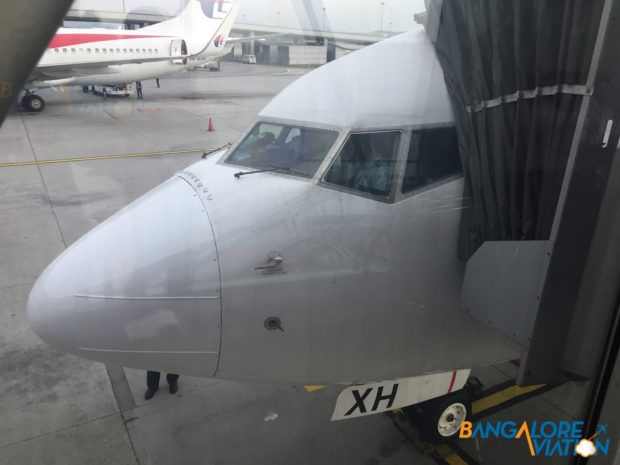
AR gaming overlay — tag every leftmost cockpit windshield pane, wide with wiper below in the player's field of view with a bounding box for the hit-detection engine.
[226,122,338,178]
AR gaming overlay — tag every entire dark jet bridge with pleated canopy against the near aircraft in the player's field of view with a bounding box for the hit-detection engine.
[424,0,620,456]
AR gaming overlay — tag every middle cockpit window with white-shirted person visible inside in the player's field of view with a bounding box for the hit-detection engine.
[323,131,400,197]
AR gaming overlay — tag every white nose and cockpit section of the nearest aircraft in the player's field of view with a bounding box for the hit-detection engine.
[28,27,518,386]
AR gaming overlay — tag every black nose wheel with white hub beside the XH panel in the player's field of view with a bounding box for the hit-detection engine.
[403,391,471,443]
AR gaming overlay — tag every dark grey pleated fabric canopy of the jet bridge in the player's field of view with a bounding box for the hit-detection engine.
[431,0,603,258]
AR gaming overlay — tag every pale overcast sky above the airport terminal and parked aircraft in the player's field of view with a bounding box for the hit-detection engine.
[72,0,424,32]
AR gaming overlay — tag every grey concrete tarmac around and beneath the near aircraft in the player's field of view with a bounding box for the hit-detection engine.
[0,62,600,465]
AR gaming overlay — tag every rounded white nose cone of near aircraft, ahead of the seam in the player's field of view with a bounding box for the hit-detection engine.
[28,177,221,376]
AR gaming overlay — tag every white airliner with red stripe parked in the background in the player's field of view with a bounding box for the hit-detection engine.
[21,0,237,112]
